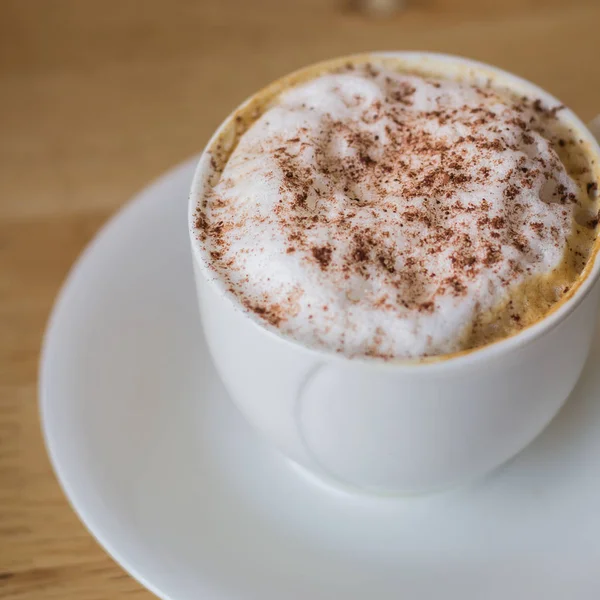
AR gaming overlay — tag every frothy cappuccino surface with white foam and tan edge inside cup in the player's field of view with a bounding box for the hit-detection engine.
[196,60,598,359]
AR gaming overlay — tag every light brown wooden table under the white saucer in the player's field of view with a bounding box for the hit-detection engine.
[0,0,600,600]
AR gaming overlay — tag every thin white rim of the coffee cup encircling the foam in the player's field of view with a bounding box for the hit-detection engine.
[188,51,600,373]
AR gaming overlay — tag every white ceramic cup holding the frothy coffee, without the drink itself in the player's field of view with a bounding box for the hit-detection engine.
[189,52,600,494]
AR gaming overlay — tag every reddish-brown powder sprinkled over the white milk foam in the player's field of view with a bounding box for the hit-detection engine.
[196,65,595,352]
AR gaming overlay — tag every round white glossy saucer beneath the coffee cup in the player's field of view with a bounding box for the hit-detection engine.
[41,162,600,600]
